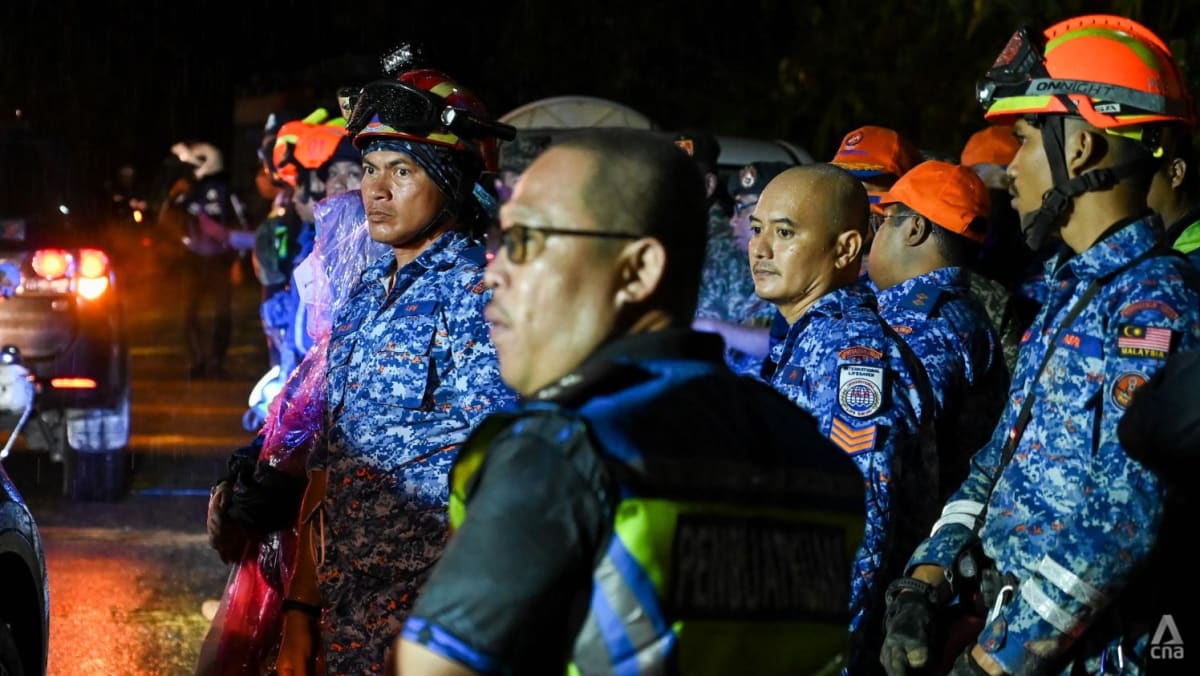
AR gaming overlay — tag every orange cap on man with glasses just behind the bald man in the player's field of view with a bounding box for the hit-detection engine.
[880,160,991,241]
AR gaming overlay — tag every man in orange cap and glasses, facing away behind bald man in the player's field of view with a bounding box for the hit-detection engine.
[869,161,1008,501]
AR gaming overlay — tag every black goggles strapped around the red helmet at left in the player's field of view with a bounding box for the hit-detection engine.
[337,80,517,140]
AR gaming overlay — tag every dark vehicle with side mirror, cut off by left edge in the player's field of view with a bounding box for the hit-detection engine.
[0,347,50,676]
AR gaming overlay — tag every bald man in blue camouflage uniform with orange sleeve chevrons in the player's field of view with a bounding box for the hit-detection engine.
[749,164,937,674]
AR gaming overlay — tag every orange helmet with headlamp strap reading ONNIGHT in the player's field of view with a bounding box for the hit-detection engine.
[977,14,1195,130]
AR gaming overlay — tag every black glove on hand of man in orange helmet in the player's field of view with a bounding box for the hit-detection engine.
[880,578,935,676]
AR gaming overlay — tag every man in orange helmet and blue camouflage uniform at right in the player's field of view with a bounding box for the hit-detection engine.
[881,16,1200,675]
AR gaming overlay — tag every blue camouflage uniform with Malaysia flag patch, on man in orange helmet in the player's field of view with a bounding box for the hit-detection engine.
[910,217,1200,674]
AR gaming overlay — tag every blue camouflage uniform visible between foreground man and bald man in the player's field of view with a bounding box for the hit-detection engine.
[696,207,775,375]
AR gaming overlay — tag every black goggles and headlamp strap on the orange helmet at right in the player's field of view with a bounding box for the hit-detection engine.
[976,26,1188,116]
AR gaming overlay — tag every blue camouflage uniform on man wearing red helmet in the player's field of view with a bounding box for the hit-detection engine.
[313,233,515,674]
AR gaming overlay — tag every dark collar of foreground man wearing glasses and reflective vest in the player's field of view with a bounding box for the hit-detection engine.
[529,329,725,405]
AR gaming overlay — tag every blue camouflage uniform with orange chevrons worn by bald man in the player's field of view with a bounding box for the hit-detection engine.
[763,283,937,674]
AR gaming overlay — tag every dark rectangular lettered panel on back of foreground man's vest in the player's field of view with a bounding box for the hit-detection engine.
[670,515,850,620]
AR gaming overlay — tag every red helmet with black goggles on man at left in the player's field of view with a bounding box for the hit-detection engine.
[338,68,516,172]
